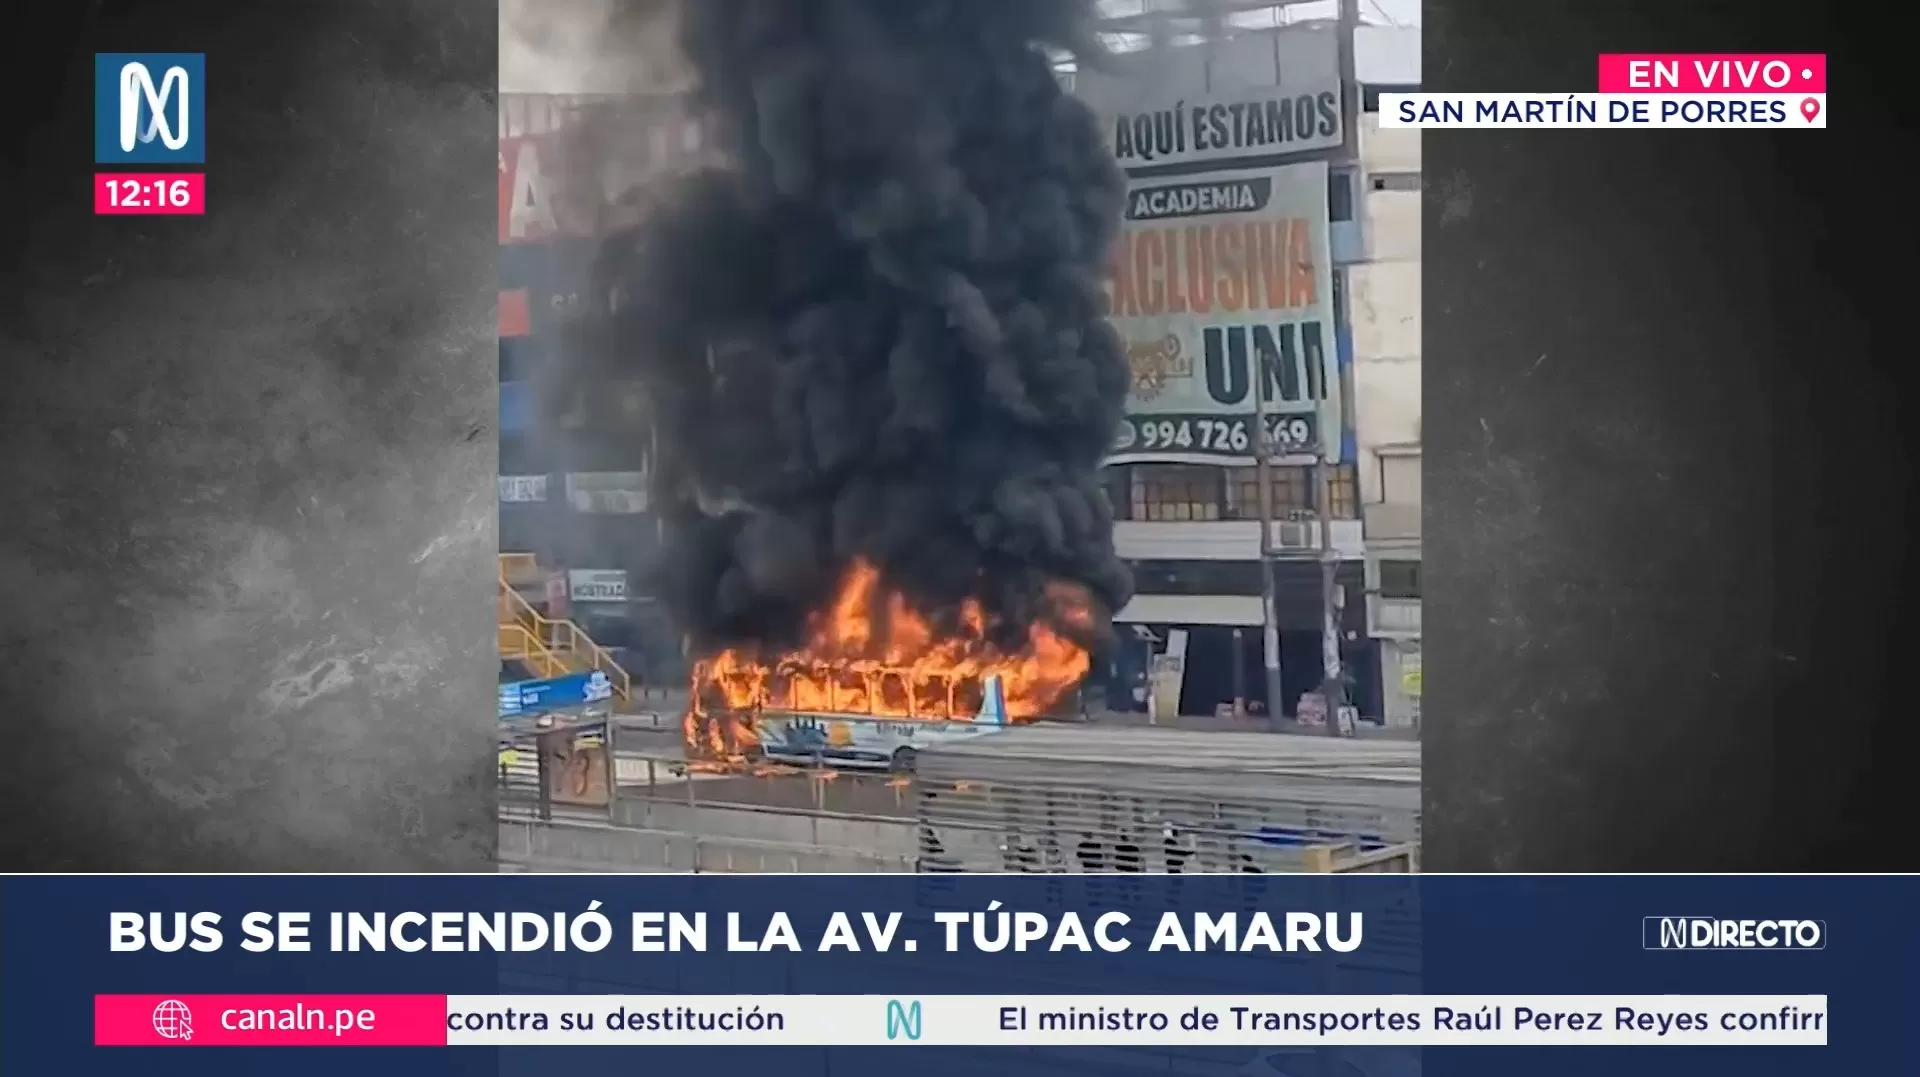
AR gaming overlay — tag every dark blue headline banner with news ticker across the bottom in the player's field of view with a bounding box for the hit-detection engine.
[0,879,1920,1077]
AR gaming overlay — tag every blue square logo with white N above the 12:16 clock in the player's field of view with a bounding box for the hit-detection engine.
[94,52,207,165]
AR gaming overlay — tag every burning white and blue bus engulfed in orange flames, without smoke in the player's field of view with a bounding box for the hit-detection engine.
[684,562,1091,770]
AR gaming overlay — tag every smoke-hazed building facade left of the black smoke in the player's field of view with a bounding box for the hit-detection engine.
[499,94,701,683]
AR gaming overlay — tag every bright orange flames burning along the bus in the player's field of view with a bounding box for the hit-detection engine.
[684,561,1092,762]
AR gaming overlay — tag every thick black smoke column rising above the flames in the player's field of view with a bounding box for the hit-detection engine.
[601,0,1131,649]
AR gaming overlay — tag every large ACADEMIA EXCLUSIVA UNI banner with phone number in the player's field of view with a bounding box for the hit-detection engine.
[1108,161,1342,465]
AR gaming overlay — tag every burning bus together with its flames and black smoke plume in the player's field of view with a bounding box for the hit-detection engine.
[568,0,1133,766]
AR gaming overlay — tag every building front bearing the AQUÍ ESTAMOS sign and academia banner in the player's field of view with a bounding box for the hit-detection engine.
[1069,23,1384,718]
